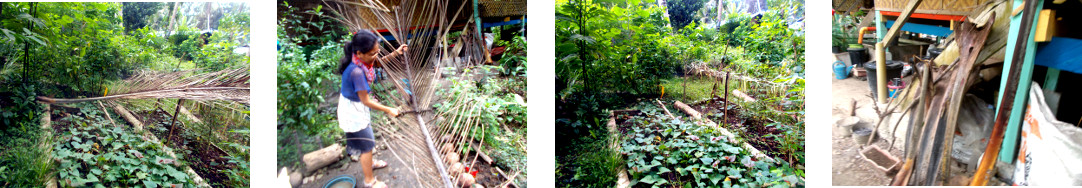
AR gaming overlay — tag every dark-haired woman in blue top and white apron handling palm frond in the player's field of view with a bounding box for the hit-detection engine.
[334,30,407,187]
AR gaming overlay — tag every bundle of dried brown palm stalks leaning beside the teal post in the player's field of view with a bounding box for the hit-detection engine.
[891,7,997,186]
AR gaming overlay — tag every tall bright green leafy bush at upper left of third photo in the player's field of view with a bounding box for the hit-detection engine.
[556,1,678,96]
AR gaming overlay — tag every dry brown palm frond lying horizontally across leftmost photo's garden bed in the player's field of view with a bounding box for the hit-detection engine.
[37,67,250,104]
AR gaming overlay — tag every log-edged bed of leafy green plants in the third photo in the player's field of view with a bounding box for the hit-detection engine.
[612,105,803,187]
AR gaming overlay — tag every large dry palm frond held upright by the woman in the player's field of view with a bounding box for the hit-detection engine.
[324,0,495,187]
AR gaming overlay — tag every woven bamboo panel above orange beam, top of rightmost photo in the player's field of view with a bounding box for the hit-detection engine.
[875,0,992,15]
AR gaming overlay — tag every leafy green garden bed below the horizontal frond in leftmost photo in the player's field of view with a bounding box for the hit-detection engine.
[50,103,199,187]
